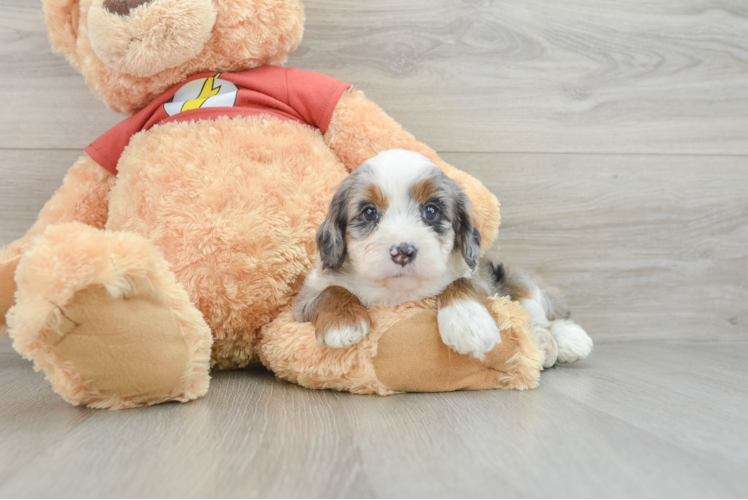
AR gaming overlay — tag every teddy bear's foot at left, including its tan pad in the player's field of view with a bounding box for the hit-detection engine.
[7,223,212,408]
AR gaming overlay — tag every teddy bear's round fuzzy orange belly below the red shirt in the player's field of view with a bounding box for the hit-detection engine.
[106,117,347,368]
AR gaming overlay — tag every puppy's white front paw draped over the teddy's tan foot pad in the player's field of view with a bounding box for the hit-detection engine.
[437,300,501,360]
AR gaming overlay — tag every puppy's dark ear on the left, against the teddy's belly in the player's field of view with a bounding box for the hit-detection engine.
[317,176,352,269]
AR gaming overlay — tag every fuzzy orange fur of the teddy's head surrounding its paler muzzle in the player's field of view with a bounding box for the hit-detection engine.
[44,0,304,113]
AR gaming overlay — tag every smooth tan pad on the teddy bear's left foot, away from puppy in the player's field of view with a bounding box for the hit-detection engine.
[45,285,190,402]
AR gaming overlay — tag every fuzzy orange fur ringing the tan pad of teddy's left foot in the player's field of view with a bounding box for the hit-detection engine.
[7,223,212,408]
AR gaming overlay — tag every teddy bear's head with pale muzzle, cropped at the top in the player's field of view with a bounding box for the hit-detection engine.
[44,0,304,113]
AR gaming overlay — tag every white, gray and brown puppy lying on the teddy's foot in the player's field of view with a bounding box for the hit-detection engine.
[294,150,592,366]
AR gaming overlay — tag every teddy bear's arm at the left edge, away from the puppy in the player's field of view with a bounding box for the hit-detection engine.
[0,156,115,263]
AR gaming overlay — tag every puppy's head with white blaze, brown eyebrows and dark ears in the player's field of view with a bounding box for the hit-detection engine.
[317,150,480,290]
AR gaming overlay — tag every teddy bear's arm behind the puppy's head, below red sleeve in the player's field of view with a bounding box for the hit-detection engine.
[324,90,499,252]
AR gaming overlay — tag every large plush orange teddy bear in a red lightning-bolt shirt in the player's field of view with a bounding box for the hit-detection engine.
[0,0,540,408]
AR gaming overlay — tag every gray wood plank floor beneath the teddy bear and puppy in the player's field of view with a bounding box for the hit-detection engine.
[0,339,748,498]
